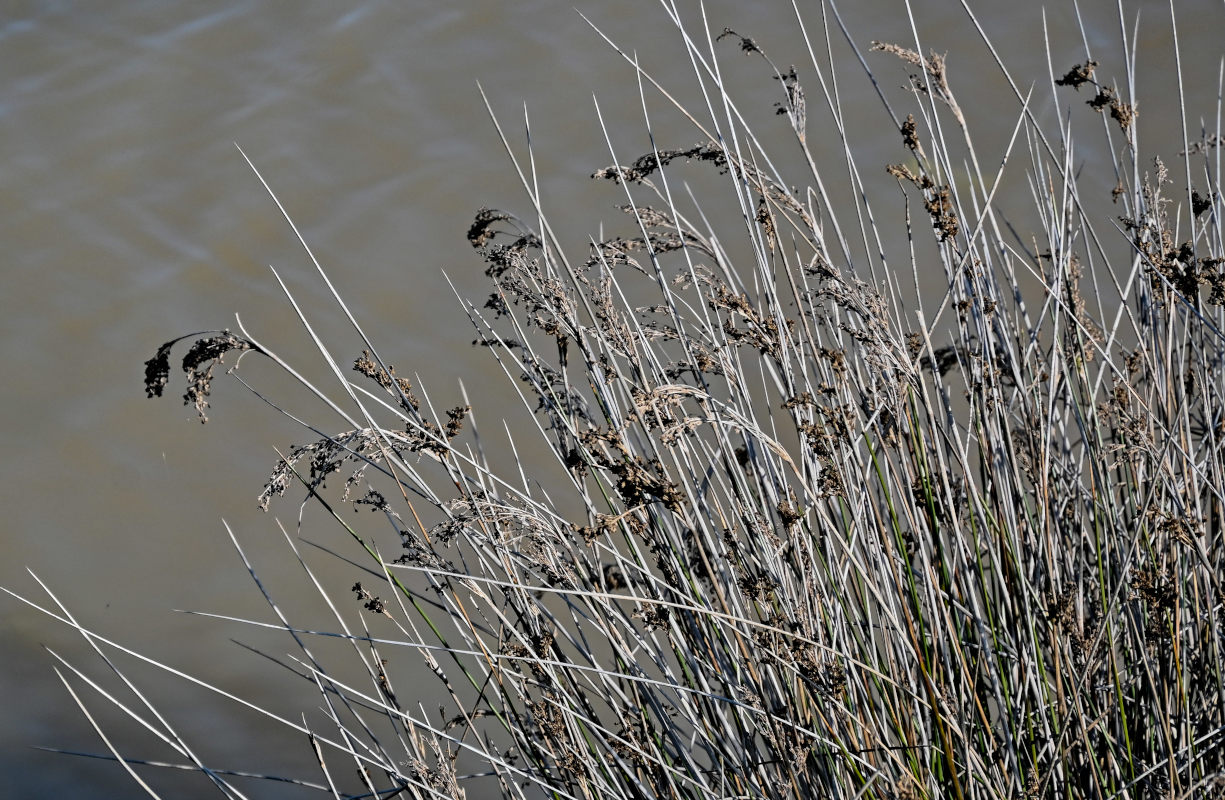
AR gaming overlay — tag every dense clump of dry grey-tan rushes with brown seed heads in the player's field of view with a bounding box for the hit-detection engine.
[11,1,1225,799]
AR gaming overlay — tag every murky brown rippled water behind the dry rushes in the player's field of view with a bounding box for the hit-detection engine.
[0,0,1225,798]
